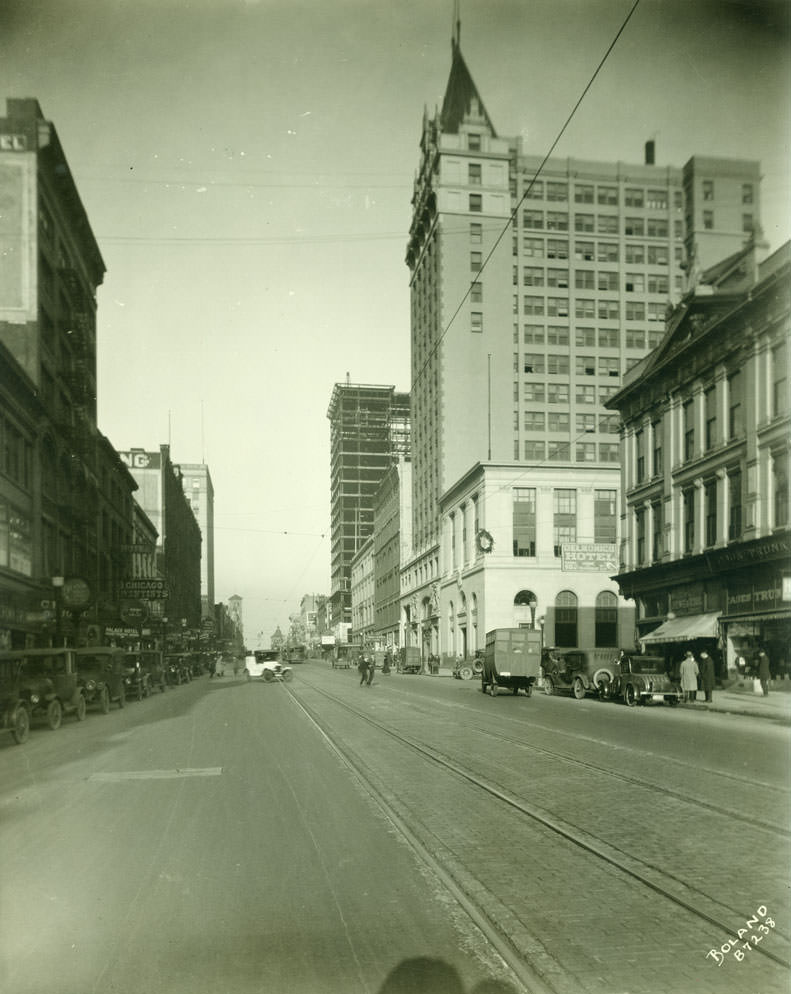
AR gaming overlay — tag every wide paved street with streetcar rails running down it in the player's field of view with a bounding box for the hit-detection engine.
[0,662,791,994]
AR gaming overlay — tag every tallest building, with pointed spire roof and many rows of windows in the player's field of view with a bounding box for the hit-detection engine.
[402,29,760,651]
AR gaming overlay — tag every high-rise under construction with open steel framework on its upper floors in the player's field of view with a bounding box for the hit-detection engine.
[327,380,410,633]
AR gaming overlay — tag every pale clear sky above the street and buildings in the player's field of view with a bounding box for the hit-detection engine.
[0,0,791,646]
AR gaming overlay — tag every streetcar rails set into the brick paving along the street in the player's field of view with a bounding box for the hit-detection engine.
[289,684,791,989]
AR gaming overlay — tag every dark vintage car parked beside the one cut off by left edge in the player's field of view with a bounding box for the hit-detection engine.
[0,648,86,729]
